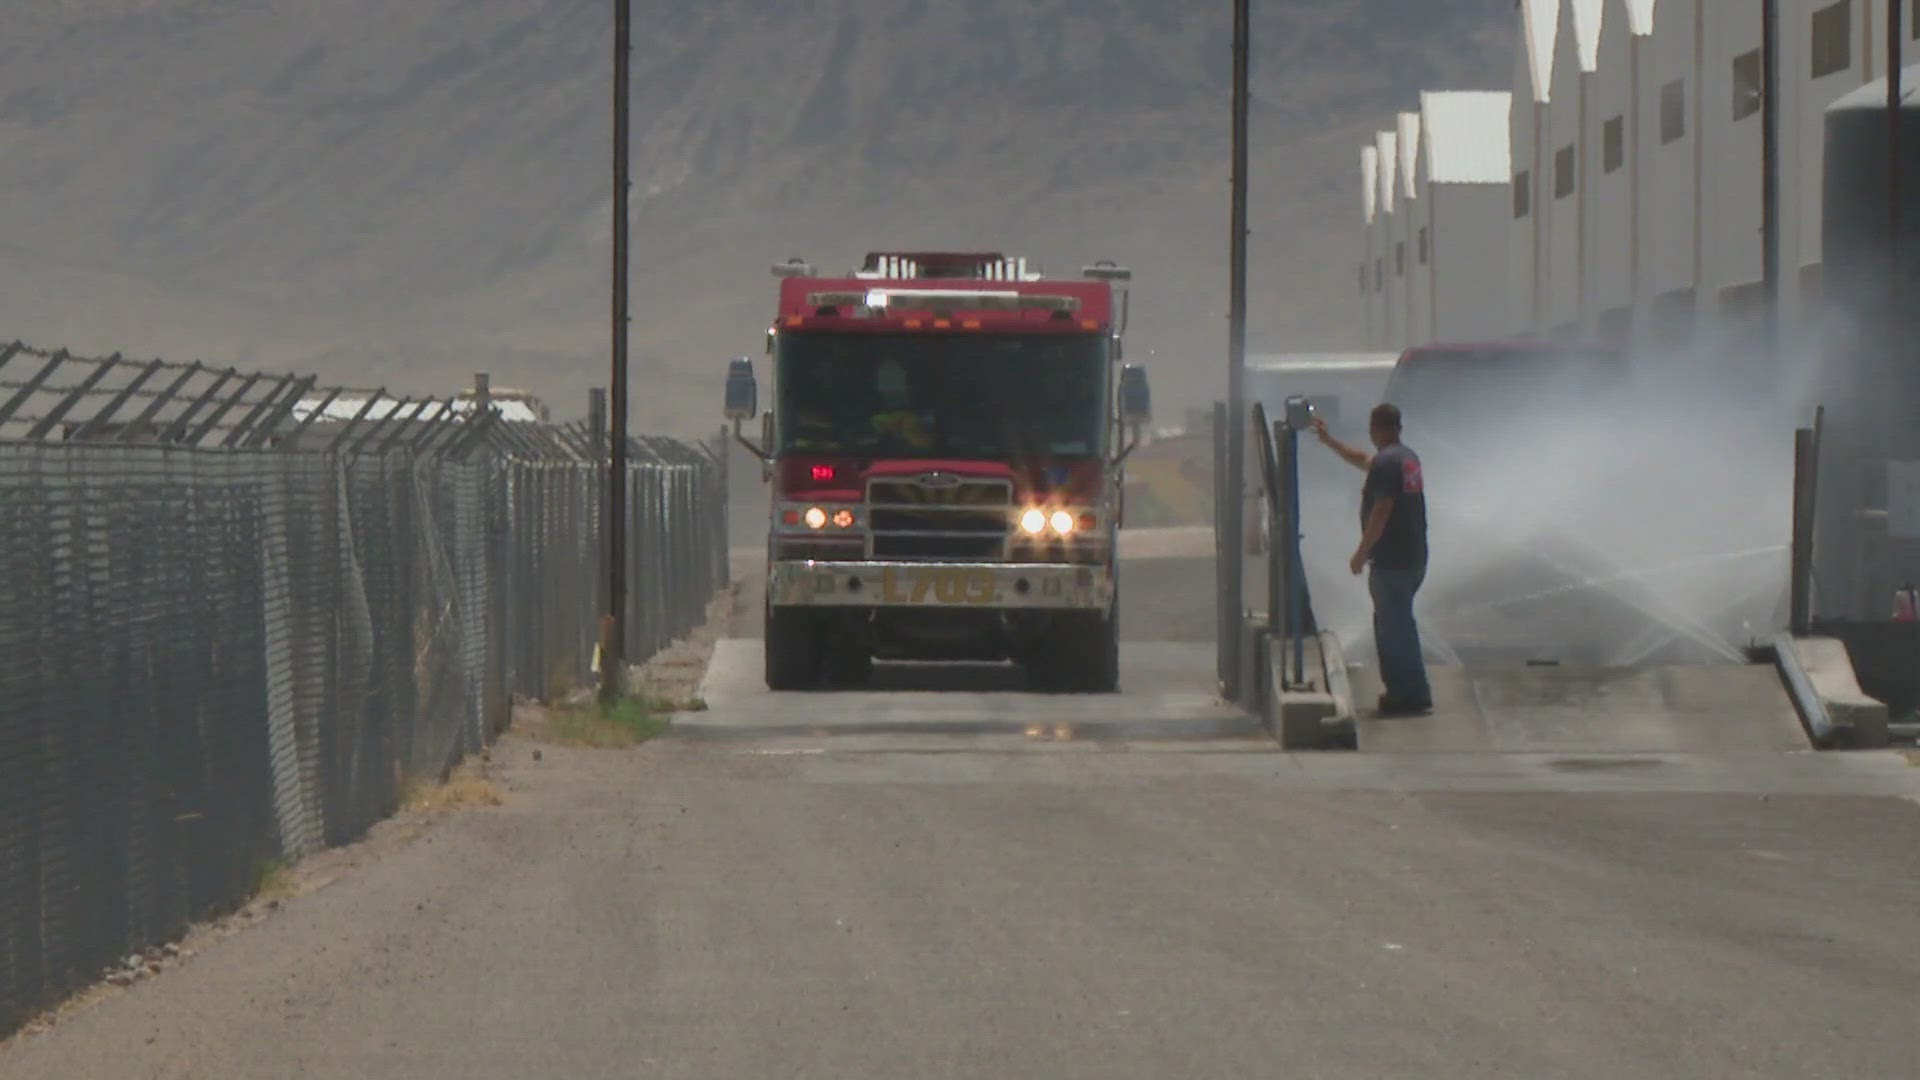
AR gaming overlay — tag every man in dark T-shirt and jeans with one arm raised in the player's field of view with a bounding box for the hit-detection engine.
[1313,405,1432,717]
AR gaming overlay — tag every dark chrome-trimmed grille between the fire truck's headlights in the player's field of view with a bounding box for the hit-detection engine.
[868,477,1014,561]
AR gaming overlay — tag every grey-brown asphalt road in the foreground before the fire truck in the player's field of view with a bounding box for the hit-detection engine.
[0,541,1920,1080]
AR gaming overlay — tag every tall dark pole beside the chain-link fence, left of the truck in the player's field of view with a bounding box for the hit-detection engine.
[599,0,634,703]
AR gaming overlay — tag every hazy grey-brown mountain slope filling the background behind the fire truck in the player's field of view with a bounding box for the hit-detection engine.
[0,0,1513,429]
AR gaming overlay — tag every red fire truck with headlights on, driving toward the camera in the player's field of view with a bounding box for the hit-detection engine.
[726,252,1148,692]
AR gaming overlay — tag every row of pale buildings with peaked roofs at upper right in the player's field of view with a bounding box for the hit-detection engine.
[1363,0,1920,350]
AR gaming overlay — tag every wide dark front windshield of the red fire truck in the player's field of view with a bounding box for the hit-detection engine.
[776,332,1108,459]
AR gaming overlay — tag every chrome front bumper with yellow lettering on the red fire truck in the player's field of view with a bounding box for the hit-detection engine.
[766,561,1114,611]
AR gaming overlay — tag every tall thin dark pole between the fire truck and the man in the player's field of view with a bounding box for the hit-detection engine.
[1217,0,1252,698]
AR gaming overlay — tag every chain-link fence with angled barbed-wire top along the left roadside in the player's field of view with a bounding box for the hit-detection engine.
[0,346,728,1034]
